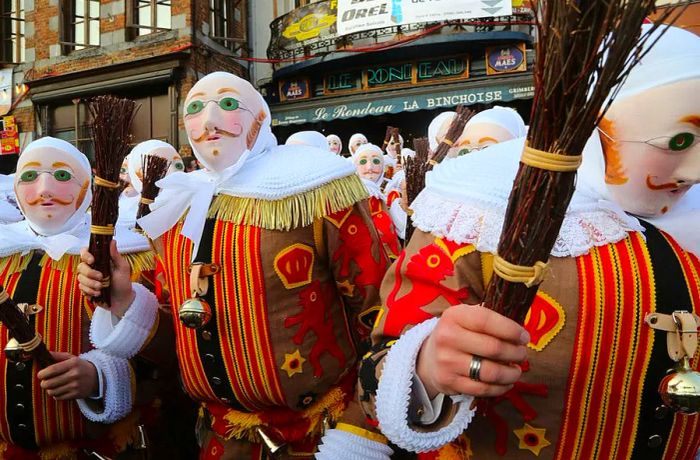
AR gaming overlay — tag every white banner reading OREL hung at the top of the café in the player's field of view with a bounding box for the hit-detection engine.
[337,0,513,35]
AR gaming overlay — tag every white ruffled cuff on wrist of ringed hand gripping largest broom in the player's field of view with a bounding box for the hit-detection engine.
[376,318,474,452]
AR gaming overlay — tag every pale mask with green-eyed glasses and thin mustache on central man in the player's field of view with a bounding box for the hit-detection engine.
[184,72,270,172]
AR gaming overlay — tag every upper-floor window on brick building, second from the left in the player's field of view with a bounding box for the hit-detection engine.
[61,0,100,54]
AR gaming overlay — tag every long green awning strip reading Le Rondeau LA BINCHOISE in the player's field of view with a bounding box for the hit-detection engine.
[272,78,535,126]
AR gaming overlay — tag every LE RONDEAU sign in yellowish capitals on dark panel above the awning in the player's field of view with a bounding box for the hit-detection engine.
[323,56,469,95]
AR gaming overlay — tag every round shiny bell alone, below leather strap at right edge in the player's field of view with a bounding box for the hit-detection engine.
[659,356,700,415]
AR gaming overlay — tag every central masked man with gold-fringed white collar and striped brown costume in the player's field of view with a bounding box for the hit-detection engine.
[81,72,388,459]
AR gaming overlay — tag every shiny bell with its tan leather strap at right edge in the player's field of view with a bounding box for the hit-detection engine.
[645,311,700,415]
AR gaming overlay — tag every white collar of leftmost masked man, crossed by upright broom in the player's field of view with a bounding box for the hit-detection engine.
[0,214,151,260]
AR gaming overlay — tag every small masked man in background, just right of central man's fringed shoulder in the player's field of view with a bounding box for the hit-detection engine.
[352,144,401,260]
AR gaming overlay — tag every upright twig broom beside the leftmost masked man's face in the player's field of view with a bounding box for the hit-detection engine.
[88,96,136,307]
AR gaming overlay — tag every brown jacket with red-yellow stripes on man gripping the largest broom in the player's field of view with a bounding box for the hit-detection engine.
[360,224,700,459]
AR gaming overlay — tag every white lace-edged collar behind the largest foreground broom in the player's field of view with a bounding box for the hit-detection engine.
[411,138,643,257]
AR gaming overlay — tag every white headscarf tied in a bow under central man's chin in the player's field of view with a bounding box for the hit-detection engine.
[138,72,278,256]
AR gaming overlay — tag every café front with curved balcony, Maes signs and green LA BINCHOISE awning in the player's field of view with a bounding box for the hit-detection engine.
[251,0,534,150]
